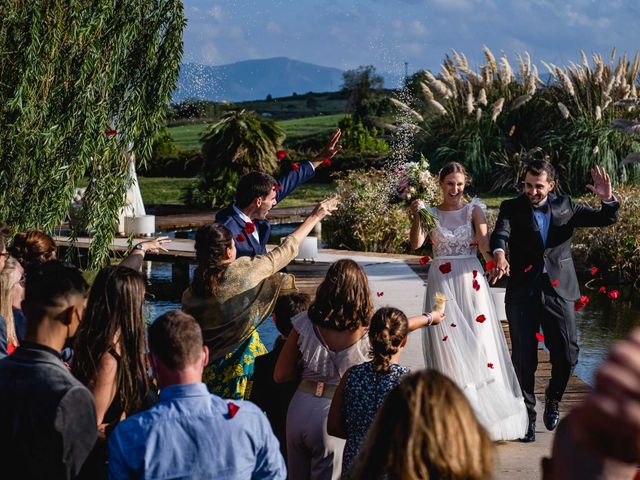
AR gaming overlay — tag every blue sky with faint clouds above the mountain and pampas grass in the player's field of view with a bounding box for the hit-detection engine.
[184,0,640,85]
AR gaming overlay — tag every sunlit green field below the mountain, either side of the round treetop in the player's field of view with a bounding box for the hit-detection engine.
[169,114,344,151]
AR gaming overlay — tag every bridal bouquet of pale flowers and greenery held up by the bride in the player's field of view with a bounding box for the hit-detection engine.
[397,156,440,232]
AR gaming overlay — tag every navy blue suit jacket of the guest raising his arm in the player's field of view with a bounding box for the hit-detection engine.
[216,162,315,257]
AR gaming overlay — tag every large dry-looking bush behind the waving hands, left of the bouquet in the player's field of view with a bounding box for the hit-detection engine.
[325,169,410,253]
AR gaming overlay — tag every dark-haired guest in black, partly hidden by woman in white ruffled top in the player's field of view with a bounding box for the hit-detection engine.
[250,293,311,458]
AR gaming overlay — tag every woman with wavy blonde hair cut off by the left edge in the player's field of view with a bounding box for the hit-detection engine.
[0,257,27,355]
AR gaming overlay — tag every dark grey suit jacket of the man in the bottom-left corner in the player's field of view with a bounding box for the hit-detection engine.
[0,341,97,479]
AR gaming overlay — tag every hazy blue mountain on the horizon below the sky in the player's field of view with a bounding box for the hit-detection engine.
[173,57,342,102]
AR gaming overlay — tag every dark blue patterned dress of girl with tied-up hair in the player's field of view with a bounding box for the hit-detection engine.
[342,362,410,478]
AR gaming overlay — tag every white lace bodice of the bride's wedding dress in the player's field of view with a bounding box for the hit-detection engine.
[431,198,487,257]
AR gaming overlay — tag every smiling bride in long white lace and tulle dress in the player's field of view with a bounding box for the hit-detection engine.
[410,162,528,440]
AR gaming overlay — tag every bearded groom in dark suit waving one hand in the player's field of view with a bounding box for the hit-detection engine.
[491,160,619,442]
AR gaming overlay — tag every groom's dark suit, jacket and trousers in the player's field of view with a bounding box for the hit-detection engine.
[491,194,619,419]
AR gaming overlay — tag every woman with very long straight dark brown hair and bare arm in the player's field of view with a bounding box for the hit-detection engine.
[71,266,151,478]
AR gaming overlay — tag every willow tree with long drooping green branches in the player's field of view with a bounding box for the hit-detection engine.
[0,0,185,267]
